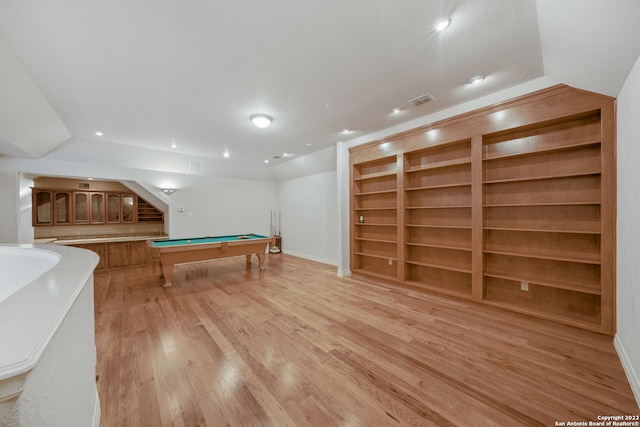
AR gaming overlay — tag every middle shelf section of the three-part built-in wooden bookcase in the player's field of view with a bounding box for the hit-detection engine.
[404,140,471,296]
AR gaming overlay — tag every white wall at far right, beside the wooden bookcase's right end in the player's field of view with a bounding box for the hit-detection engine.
[615,51,640,404]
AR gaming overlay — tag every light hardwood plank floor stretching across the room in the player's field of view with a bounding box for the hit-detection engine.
[95,254,640,427]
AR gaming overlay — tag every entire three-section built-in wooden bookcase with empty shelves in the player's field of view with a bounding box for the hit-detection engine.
[350,85,616,335]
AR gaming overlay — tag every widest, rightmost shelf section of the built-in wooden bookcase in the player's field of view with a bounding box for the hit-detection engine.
[483,111,603,325]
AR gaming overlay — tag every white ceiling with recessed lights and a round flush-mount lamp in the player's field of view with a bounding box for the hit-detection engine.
[0,0,640,172]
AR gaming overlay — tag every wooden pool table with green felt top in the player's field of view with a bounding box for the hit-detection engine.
[147,234,274,287]
